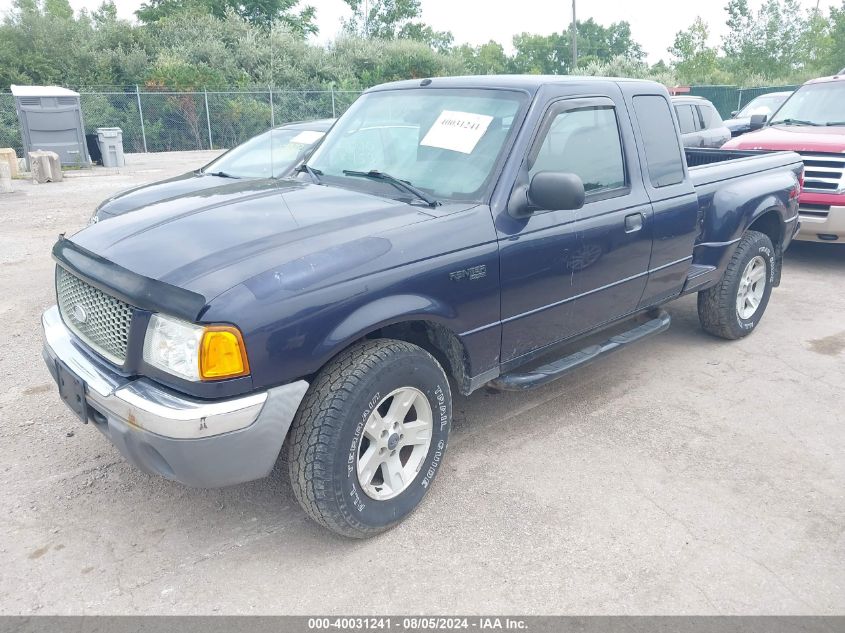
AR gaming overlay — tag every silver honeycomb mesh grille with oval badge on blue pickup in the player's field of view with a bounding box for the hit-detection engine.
[56,266,133,365]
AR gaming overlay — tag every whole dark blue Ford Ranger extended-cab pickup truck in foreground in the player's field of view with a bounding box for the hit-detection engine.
[43,76,803,537]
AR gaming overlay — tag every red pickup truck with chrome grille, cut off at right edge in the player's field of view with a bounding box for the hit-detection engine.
[722,69,845,243]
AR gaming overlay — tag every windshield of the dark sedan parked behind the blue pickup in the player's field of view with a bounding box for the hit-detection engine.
[202,129,324,178]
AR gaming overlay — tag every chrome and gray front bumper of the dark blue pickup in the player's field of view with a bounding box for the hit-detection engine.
[41,306,308,488]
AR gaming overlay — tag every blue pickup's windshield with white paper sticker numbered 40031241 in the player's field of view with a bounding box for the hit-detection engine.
[308,88,527,200]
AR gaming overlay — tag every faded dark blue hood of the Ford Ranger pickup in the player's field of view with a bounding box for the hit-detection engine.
[70,180,448,301]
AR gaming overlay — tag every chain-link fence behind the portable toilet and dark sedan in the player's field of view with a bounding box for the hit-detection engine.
[0,87,361,156]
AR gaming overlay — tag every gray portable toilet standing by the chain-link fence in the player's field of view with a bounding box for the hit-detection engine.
[12,85,91,169]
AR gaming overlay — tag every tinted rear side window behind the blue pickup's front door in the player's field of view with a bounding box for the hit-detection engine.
[634,95,684,188]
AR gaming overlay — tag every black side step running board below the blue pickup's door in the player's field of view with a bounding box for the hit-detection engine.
[489,310,672,391]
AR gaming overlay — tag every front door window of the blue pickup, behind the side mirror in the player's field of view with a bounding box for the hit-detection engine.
[529,106,625,196]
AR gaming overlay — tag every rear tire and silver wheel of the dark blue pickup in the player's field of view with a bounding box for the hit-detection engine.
[698,231,775,340]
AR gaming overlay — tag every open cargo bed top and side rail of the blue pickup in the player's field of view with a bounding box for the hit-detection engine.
[684,148,801,187]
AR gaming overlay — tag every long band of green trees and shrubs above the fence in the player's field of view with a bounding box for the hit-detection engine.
[0,0,845,90]
